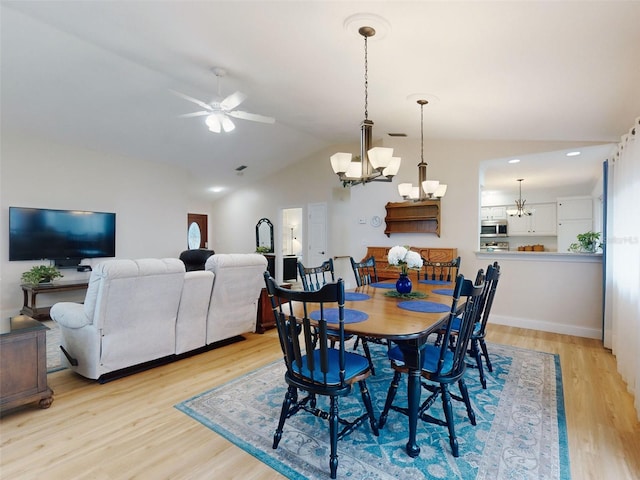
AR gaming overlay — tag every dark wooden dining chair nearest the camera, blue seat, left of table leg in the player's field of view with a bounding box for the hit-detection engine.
[264,272,378,478]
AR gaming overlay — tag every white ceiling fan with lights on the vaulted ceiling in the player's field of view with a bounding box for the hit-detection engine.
[172,67,276,133]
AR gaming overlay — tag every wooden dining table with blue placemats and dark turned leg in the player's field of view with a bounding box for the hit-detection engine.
[336,280,461,457]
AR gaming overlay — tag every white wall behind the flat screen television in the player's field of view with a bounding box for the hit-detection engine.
[0,132,210,317]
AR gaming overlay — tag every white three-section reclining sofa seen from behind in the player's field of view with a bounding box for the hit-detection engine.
[50,254,267,379]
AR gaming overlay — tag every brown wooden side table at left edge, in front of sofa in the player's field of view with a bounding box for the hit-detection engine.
[0,315,53,410]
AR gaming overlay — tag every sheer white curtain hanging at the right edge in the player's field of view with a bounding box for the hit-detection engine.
[605,117,640,419]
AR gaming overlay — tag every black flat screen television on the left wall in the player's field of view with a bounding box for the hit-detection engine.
[9,207,116,267]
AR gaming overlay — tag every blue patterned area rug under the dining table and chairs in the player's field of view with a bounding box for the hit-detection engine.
[176,344,570,480]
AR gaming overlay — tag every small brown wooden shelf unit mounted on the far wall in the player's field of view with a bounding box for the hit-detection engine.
[384,200,440,237]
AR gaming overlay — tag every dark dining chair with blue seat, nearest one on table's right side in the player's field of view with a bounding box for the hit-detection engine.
[378,272,484,457]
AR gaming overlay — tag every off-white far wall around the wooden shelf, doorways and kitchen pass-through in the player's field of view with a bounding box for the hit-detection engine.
[212,138,601,338]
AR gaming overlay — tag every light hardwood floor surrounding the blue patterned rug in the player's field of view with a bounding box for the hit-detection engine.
[0,325,640,480]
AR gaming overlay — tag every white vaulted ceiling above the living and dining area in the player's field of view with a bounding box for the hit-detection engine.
[0,0,640,197]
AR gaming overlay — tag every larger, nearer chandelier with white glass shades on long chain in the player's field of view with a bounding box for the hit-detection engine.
[330,26,400,187]
